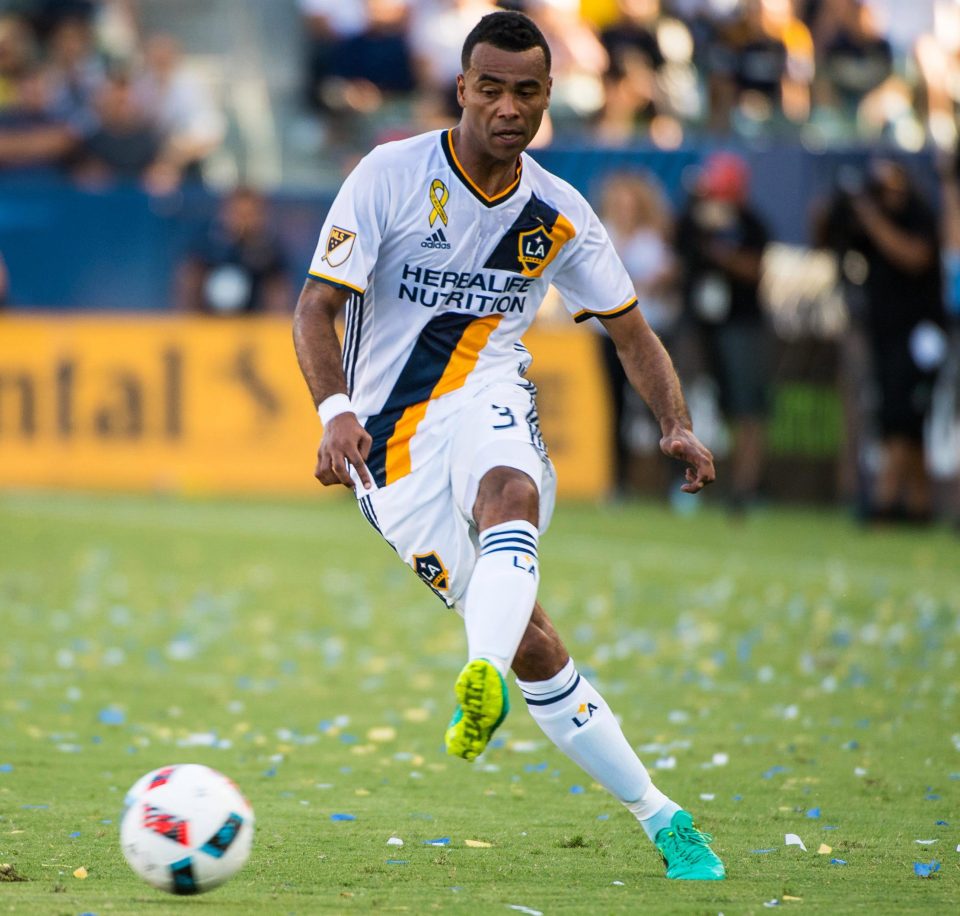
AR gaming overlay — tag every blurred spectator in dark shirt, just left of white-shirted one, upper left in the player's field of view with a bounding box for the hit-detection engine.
[74,72,173,193]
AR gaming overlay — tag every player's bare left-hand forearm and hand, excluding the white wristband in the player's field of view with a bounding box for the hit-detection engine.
[293,280,372,489]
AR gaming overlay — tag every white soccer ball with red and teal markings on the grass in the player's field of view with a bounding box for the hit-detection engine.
[120,763,253,894]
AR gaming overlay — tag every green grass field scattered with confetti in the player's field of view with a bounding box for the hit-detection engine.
[0,493,960,916]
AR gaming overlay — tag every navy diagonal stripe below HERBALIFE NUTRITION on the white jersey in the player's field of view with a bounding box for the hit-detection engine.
[366,312,476,487]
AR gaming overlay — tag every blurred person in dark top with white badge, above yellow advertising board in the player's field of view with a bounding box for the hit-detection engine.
[177,187,294,315]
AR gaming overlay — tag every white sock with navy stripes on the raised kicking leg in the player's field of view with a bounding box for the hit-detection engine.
[463,521,540,676]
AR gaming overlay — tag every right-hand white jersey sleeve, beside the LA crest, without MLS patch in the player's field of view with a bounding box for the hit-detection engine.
[553,210,637,321]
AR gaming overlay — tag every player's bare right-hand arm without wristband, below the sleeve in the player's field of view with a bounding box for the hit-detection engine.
[601,309,716,493]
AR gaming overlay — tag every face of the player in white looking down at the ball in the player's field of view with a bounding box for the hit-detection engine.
[457,43,551,162]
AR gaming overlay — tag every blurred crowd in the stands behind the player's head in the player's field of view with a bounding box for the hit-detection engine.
[0,0,960,184]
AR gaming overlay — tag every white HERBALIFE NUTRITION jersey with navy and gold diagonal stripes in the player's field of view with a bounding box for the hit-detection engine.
[310,131,636,486]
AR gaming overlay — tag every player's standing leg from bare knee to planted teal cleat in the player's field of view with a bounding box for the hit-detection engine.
[513,604,724,880]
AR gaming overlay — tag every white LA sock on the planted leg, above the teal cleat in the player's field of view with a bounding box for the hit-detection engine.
[517,659,679,829]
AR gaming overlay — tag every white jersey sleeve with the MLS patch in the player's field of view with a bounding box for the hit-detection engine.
[309,151,389,293]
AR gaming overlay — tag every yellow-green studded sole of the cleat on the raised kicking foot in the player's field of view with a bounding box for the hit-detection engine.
[444,658,510,760]
